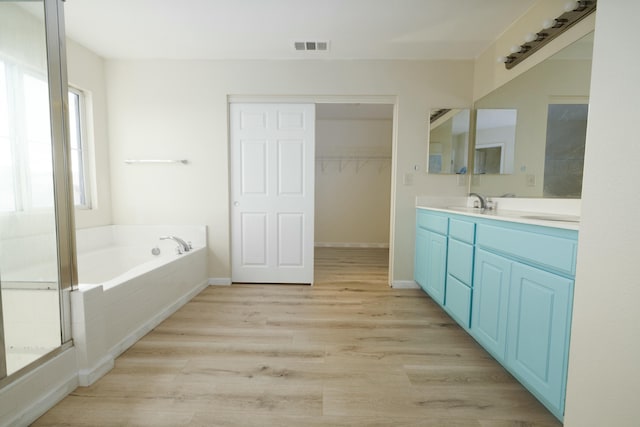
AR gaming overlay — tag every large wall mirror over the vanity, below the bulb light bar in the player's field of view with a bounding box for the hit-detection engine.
[470,33,593,198]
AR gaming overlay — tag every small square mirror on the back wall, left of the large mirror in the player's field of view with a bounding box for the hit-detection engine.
[427,109,471,174]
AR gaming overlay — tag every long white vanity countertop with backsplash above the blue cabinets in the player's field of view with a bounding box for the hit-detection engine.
[416,197,580,230]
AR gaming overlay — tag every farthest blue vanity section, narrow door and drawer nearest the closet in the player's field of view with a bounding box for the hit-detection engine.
[414,210,449,305]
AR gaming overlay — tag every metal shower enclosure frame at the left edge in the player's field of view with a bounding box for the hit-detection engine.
[0,0,78,388]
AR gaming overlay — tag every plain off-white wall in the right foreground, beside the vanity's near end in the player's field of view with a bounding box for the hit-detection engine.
[565,0,640,427]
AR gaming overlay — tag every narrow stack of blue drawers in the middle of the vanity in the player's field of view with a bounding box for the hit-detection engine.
[444,217,475,329]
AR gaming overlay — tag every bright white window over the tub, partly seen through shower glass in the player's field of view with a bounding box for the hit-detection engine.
[0,59,90,212]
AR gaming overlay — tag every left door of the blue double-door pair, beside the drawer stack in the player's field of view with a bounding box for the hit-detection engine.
[471,249,512,362]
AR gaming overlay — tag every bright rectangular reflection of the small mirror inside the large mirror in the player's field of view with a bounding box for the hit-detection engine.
[473,109,518,175]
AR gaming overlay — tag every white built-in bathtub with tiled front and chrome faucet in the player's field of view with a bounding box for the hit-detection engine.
[71,225,208,385]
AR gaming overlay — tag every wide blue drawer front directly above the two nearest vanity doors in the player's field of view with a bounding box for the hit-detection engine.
[476,224,578,276]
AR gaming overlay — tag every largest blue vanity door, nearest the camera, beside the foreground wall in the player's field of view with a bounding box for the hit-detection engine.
[507,263,573,414]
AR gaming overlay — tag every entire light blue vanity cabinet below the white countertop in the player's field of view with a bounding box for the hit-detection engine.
[415,209,578,419]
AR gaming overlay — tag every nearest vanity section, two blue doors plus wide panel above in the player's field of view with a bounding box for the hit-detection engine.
[471,224,578,419]
